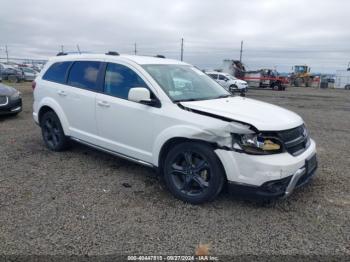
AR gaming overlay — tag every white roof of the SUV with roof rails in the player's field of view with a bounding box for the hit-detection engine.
[50,54,188,65]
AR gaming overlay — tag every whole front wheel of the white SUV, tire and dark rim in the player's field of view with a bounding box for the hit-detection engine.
[163,142,225,204]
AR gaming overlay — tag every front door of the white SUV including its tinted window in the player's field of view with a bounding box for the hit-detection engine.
[96,63,159,162]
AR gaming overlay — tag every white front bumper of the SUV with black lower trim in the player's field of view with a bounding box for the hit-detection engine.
[215,140,317,198]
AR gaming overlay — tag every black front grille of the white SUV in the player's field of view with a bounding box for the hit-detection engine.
[278,125,310,156]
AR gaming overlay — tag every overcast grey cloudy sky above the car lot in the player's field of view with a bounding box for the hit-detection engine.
[0,0,350,73]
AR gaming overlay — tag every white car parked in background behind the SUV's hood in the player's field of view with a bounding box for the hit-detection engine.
[206,71,248,93]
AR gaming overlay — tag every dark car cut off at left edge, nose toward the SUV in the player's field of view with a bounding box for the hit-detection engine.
[0,83,22,115]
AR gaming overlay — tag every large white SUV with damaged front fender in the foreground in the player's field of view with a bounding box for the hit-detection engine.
[33,53,317,204]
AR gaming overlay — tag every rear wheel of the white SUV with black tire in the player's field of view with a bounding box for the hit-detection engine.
[40,111,69,151]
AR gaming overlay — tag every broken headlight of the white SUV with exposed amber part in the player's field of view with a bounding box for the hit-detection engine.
[232,134,283,155]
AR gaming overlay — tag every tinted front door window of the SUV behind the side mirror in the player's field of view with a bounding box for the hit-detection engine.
[104,63,147,99]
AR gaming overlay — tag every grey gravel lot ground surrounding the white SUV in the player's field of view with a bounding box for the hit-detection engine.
[0,84,350,256]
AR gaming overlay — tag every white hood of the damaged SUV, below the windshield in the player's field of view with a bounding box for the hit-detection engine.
[181,96,303,131]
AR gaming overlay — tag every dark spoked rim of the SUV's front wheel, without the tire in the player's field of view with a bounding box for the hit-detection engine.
[168,151,211,196]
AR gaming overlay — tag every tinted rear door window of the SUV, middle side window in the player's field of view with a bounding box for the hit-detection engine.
[68,61,101,90]
